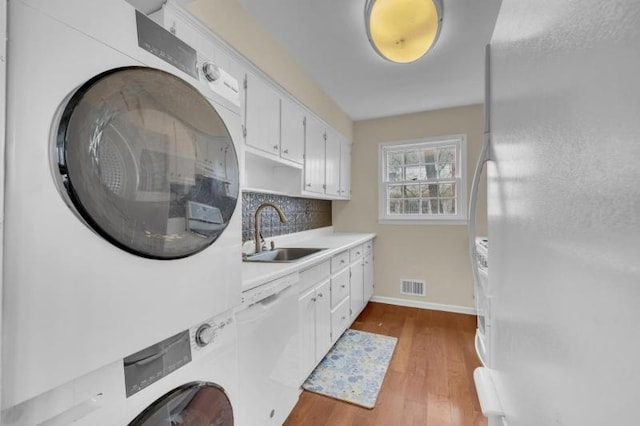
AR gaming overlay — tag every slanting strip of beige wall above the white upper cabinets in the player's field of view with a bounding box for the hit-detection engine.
[187,0,353,140]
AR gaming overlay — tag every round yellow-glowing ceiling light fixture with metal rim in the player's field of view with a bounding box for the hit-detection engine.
[364,0,442,63]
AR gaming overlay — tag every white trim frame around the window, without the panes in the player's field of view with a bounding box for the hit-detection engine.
[378,134,468,225]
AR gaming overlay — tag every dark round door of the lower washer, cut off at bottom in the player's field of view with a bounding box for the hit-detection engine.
[129,382,233,426]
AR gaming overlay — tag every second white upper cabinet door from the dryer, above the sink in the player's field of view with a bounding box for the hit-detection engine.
[280,98,305,164]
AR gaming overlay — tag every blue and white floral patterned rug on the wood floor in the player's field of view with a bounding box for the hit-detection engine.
[302,329,398,408]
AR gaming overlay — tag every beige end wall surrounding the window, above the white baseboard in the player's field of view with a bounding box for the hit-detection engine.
[333,105,487,307]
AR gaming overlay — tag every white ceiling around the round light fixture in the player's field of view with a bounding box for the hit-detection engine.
[238,0,501,120]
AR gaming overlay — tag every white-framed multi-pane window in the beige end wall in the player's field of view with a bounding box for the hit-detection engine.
[379,135,467,224]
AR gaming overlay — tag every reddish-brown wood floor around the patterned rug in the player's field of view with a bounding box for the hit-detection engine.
[284,302,487,426]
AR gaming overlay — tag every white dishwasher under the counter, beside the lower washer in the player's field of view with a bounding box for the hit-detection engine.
[237,272,300,426]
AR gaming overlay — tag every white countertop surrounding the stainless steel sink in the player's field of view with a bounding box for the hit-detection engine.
[242,227,376,292]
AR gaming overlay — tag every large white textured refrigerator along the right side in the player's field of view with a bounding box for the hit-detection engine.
[474,0,640,426]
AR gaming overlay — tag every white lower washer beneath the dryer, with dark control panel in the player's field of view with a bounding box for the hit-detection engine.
[2,311,238,426]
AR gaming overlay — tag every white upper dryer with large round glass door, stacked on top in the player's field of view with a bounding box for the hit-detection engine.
[2,0,241,410]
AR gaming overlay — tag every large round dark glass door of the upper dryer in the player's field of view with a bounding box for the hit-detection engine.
[57,67,239,259]
